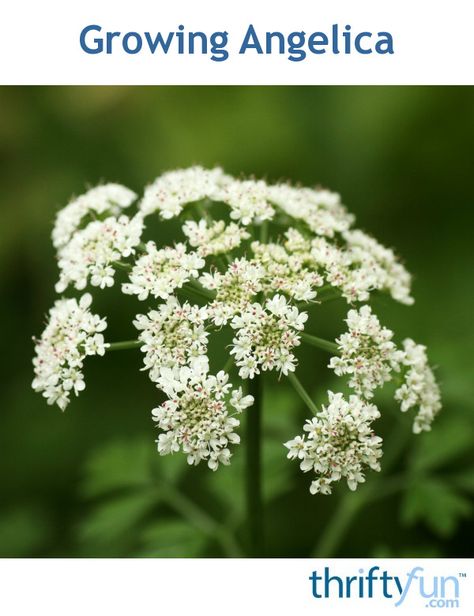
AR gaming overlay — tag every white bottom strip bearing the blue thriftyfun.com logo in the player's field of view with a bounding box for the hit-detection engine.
[0,559,474,616]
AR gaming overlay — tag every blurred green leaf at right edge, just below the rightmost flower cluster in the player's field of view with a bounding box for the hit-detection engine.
[413,418,474,471]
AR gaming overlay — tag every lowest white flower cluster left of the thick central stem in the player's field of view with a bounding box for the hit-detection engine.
[152,367,253,471]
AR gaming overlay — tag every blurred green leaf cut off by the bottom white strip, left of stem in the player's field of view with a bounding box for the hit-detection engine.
[140,520,207,558]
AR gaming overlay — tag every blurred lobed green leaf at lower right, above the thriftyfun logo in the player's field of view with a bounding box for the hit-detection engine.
[402,478,471,537]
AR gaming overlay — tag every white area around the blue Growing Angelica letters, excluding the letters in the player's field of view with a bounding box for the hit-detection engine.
[0,0,474,85]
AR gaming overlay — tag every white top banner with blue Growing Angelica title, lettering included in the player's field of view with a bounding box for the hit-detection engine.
[0,0,474,85]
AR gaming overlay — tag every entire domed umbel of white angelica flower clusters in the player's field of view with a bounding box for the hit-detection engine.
[33,167,441,494]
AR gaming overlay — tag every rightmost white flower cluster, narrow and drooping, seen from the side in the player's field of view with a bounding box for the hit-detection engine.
[395,338,441,434]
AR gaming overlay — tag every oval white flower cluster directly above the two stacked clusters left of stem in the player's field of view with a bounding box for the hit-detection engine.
[122,241,205,300]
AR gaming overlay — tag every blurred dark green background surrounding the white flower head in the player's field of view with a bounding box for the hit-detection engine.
[0,87,474,557]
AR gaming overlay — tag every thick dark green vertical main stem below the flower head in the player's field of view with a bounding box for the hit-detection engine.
[245,375,264,556]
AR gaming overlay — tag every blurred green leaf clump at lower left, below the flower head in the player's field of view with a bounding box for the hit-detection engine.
[79,437,202,556]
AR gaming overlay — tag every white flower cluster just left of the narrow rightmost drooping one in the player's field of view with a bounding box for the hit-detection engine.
[329,306,403,399]
